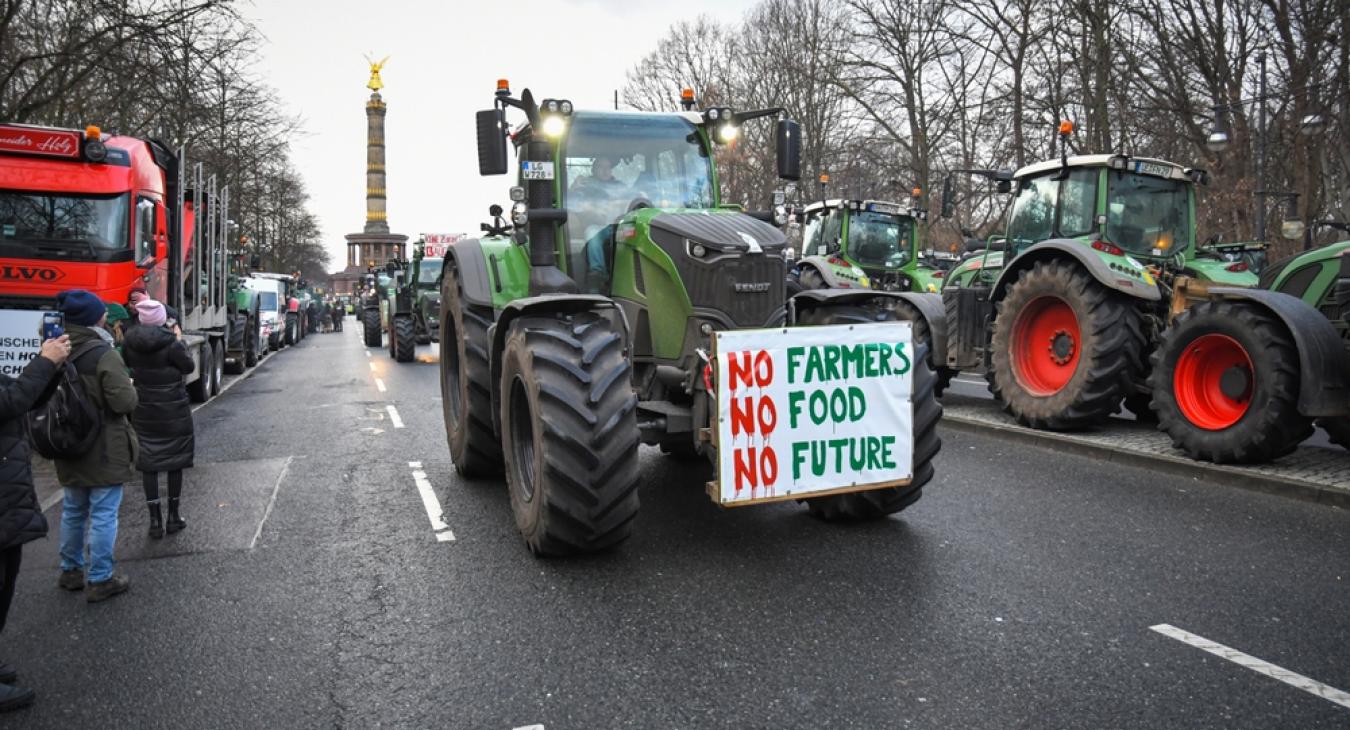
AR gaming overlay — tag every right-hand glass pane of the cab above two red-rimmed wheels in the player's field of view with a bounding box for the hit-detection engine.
[1106,171,1191,256]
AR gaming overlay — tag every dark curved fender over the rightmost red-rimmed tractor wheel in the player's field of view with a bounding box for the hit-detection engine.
[1210,286,1350,418]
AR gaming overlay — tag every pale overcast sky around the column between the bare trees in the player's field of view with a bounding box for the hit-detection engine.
[251,0,753,270]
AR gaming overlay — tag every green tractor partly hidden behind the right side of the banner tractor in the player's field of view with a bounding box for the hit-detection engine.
[787,187,954,395]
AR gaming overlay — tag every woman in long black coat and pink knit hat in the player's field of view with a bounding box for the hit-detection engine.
[122,300,196,538]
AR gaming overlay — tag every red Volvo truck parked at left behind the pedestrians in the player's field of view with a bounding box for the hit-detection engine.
[0,124,232,402]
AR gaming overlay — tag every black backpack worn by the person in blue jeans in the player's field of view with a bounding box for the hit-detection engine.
[28,340,107,459]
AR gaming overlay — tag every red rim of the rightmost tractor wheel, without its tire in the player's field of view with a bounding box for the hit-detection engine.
[1172,333,1256,430]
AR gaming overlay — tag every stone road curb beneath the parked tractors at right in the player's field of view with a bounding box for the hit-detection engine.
[941,414,1350,509]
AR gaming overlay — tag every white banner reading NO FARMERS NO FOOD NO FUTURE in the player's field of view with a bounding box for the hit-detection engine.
[713,322,914,506]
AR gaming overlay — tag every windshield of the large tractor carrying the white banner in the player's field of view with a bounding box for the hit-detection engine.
[560,112,717,283]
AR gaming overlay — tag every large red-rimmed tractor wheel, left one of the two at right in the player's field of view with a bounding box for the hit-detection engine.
[990,260,1145,430]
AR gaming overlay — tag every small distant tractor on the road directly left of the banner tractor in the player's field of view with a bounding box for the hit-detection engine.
[379,240,443,363]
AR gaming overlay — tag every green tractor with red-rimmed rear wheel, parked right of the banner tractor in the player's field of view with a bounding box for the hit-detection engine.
[934,125,1257,429]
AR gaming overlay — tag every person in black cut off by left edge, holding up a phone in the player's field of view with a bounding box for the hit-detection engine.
[0,335,70,712]
